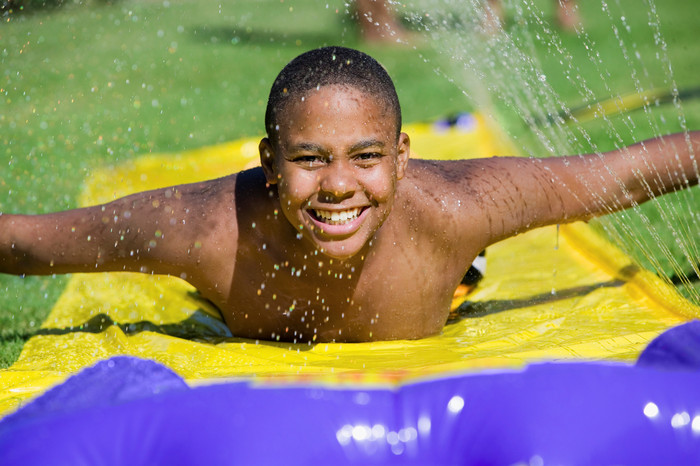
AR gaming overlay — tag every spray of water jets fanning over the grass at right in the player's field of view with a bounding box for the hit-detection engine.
[400,0,700,303]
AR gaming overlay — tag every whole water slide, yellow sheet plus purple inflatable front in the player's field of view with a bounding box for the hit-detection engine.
[0,115,700,465]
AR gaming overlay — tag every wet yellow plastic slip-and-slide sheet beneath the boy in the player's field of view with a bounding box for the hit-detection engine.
[0,116,700,414]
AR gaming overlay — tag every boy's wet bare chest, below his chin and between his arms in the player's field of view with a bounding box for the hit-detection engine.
[220,237,461,342]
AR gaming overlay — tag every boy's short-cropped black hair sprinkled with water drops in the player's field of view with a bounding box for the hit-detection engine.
[265,46,401,144]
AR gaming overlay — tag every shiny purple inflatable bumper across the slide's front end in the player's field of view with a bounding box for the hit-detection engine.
[0,322,700,465]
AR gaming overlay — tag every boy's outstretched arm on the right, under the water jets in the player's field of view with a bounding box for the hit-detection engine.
[451,131,700,246]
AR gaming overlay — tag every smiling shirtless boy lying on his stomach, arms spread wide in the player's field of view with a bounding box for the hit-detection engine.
[0,47,700,342]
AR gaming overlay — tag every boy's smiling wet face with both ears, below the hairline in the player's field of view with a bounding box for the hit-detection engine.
[260,85,409,259]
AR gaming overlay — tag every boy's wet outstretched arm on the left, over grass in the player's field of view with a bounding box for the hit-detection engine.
[0,180,235,288]
